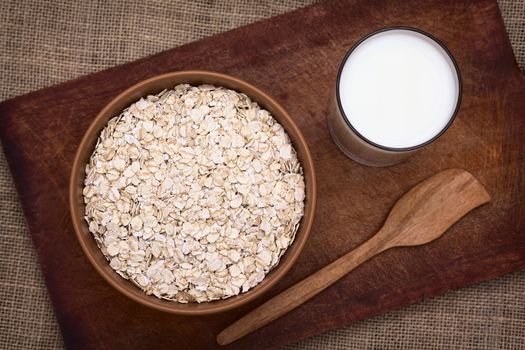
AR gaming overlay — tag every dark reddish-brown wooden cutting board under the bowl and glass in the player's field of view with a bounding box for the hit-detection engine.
[0,0,525,349]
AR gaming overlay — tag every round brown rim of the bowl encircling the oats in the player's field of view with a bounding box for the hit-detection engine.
[68,70,317,315]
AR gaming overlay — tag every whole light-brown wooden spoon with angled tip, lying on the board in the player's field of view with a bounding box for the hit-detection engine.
[217,169,490,345]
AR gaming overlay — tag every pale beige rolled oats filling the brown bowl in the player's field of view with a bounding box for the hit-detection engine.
[83,85,305,303]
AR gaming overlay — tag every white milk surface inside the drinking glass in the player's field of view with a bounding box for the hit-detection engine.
[339,29,459,148]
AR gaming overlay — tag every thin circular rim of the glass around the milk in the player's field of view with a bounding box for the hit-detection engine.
[335,26,463,152]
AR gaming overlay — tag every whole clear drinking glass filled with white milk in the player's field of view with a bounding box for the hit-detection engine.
[328,27,461,166]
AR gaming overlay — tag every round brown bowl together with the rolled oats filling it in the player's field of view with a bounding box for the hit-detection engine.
[69,71,316,315]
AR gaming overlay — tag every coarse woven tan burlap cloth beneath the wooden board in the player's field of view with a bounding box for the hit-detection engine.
[0,0,525,349]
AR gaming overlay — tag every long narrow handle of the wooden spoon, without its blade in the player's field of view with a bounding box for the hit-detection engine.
[217,235,385,345]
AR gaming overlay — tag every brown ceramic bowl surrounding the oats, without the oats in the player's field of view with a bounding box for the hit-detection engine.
[69,71,316,315]
